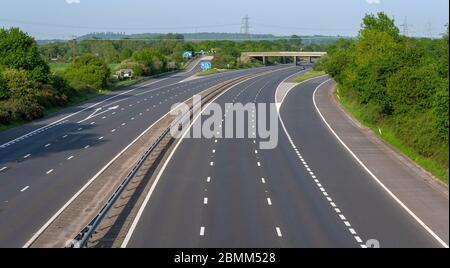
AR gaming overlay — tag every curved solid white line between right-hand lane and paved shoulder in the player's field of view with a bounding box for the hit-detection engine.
[313,79,448,248]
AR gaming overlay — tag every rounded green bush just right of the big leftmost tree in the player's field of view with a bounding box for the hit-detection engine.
[63,54,110,90]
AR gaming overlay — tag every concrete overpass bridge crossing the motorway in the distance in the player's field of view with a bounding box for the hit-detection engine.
[241,51,327,65]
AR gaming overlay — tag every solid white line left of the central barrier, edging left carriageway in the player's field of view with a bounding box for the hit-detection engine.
[23,93,190,248]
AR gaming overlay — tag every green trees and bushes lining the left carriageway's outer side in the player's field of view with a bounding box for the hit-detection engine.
[0,28,183,127]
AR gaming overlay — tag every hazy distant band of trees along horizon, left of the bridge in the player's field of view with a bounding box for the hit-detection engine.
[39,34,327,69]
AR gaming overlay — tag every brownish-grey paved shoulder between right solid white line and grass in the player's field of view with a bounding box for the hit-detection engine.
[313,80,449,245]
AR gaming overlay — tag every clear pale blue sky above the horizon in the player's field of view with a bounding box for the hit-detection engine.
[0,0,449,39]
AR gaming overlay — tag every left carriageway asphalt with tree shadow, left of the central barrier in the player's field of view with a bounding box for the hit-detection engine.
[0,62,288,247]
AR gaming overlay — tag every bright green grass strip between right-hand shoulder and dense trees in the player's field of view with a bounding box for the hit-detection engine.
[336,85,449,185]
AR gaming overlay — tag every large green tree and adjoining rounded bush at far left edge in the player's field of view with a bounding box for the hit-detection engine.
[0,28,109,124]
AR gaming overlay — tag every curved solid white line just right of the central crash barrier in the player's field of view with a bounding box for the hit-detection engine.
[120,69,284,248]
